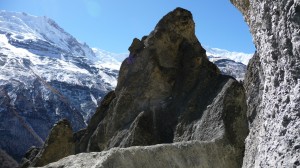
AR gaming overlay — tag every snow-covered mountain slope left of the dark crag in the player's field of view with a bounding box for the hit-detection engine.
[0,11,120,159]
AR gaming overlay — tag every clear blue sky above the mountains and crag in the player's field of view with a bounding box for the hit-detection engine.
[0,0,255,53]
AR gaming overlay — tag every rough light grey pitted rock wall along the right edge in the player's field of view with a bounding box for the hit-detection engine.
[231,0,300,167]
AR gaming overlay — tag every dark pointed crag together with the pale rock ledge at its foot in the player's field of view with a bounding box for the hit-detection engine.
[38,8,248,168]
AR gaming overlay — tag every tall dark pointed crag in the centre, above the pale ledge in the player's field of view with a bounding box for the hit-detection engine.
[79,8,247,155]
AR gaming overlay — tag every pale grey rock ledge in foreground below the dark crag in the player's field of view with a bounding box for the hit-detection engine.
[45,141,240,168]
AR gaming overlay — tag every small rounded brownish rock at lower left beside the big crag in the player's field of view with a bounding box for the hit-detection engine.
[21,119,75,168]
